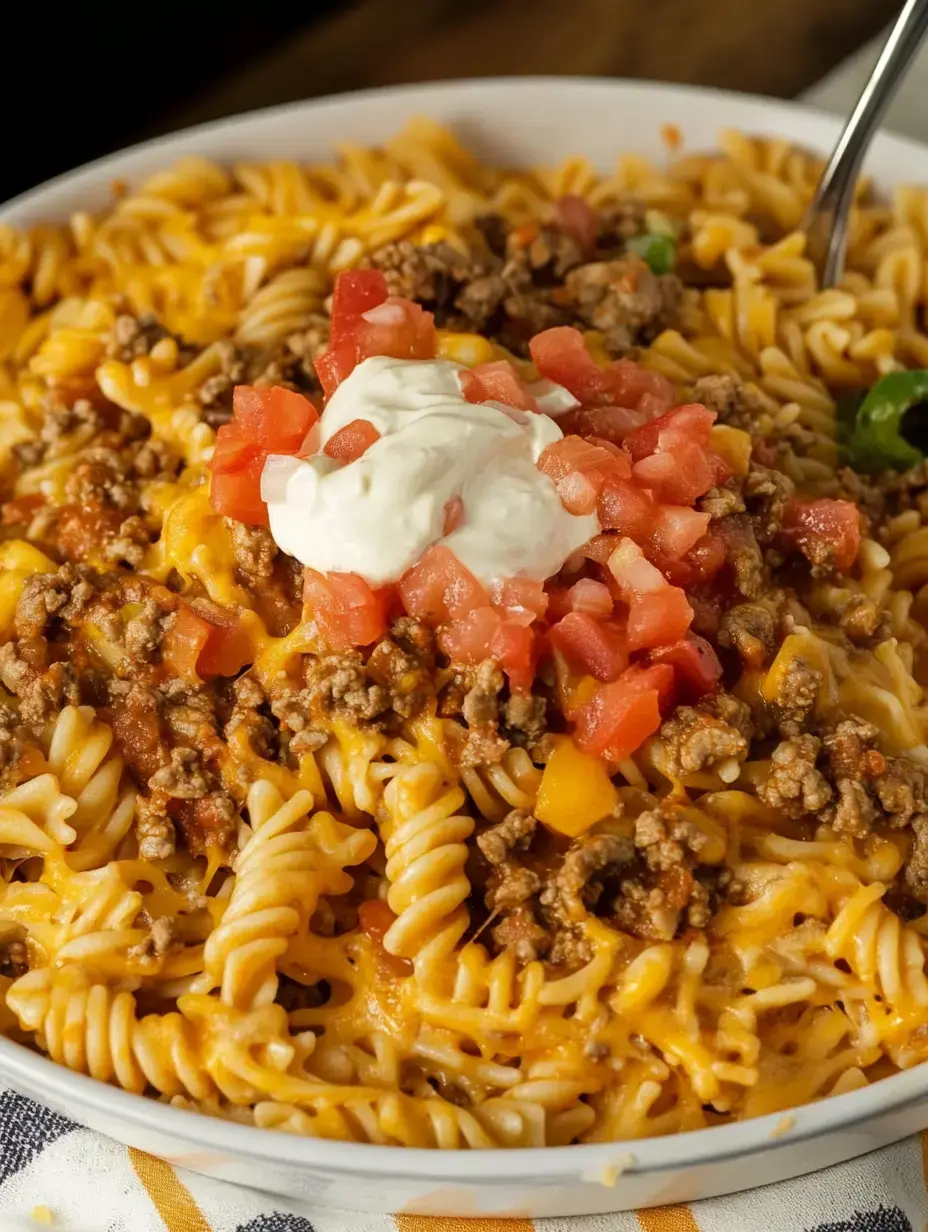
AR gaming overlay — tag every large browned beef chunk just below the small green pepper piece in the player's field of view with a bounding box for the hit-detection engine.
[563,257,683,355]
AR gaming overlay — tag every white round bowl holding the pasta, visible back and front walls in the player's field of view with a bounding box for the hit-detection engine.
[0,78,928,1216]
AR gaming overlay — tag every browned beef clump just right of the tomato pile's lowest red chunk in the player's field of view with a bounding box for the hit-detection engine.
[652,694,753,779]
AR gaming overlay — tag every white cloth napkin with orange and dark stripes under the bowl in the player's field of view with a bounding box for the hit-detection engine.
[0,1088,928,1232]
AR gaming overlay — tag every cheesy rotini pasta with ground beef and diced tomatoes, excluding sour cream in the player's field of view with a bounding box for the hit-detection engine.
[0,120,928,1149]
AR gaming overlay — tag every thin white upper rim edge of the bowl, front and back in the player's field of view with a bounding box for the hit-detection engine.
[0,74,928,1184]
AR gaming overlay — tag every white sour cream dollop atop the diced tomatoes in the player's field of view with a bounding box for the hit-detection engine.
[261,356,599,586]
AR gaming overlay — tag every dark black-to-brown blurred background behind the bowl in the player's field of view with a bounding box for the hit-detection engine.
[0,0,898,201]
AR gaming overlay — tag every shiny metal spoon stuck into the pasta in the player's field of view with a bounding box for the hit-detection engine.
[804,0,928,287]
